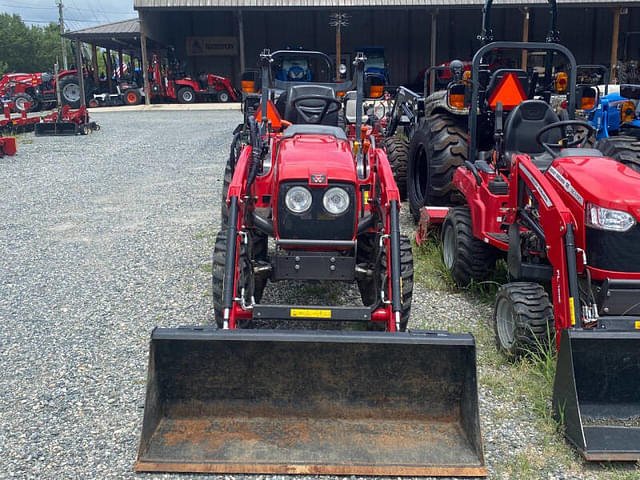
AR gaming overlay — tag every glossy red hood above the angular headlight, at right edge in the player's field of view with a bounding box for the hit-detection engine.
[546,157,640,221]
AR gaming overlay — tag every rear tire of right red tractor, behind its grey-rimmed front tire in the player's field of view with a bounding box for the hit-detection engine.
[442,206,498,287]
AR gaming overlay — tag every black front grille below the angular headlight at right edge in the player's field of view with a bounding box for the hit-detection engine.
[586,225,640,272]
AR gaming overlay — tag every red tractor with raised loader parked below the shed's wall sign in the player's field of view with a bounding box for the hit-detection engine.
[147,55,240,103]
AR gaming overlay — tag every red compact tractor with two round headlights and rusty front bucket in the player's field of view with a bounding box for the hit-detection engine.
[135,52,486,476]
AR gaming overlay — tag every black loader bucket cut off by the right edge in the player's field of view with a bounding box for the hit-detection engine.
[553,329,640,461]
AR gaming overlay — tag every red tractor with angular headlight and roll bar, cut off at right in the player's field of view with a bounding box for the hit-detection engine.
[423,42,640,461]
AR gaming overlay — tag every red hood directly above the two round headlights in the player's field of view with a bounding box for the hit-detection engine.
[277,134,357,185]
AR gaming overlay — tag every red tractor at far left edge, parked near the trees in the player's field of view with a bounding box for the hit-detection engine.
[0,70,95,112]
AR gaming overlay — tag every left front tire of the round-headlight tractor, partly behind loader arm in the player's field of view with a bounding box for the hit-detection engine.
[211,229,267,328]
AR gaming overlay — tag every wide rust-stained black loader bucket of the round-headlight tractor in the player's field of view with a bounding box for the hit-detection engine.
[135,327,486,476]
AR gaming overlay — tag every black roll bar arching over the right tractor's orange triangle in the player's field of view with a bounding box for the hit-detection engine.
[468,42,577,162]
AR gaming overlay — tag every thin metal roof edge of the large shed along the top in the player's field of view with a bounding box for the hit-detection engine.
[133,0,638,9]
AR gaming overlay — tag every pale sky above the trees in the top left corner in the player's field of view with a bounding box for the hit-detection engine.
[0,0,138,30]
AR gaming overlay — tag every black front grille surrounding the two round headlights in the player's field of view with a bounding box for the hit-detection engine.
[278,181,356,240]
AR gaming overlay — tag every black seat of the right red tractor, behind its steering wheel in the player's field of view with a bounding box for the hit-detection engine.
[504,100,562,172]
